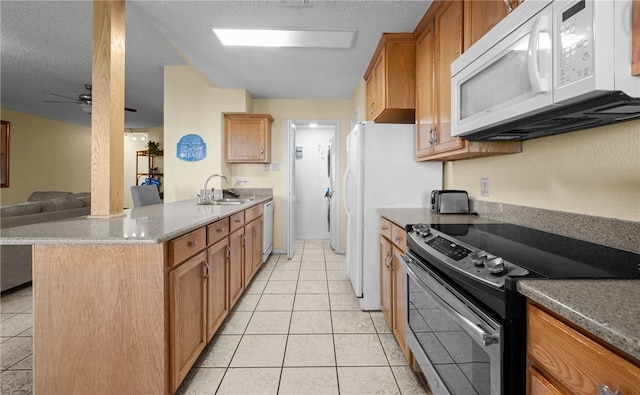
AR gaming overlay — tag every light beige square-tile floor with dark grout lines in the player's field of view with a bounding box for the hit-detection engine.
[0,240,426,395]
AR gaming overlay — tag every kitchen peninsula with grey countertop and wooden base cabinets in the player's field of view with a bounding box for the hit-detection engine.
[0,195,272,395]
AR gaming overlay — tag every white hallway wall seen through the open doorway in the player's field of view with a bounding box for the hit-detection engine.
[295,127,335,239]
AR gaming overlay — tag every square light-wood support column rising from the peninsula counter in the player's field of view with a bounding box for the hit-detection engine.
[91,0,125,218]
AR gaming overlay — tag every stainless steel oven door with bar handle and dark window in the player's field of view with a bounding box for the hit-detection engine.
[407,269,502,395]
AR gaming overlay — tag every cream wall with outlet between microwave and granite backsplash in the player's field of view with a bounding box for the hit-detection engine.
[445,120,640,222]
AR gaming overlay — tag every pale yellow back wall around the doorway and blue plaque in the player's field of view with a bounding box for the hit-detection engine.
[164,66,353,250]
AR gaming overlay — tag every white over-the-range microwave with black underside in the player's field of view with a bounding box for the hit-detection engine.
[451,0,640,141]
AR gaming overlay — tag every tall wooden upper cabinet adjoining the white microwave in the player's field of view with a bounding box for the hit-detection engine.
[414,0,522,161]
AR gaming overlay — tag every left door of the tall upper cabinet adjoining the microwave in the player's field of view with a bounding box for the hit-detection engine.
[416,21,436,158]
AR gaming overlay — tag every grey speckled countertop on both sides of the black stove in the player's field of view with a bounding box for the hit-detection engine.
[378,208,640,361]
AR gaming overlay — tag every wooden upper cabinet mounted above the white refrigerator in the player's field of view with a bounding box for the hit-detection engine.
[364,33,416,123]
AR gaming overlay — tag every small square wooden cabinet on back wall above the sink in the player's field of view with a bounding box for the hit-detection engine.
[224,114,273,163]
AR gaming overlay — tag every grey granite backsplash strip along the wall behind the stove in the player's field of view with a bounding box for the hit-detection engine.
[470,198,640,254]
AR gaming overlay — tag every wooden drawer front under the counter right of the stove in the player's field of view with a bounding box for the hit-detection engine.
[527,304,640,394]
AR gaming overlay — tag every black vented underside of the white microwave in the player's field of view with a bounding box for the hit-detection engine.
[464,92,640,141]
